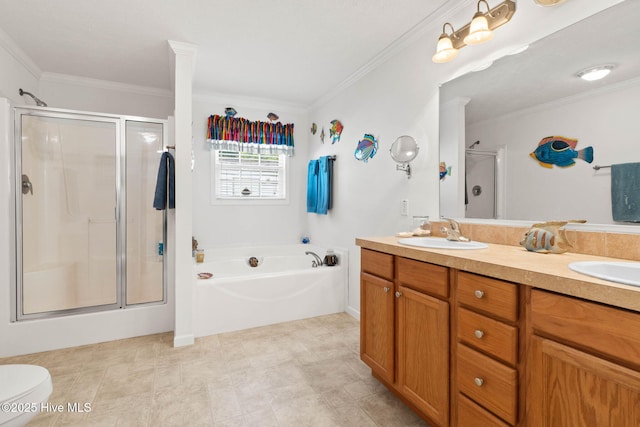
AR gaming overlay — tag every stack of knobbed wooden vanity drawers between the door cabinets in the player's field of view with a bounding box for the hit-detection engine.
[452,271,521,426]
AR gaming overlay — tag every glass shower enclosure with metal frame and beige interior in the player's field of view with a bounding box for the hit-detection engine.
[13,107,166,320]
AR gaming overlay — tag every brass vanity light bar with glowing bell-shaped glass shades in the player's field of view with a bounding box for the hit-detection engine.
[431,0,516,63]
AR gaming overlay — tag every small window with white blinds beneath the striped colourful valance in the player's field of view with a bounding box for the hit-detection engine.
[212,150,287,202]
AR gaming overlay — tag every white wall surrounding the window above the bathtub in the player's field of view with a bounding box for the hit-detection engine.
[193,95,309,248]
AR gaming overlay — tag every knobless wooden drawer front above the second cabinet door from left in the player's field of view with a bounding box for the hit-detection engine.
[396,257,449,298]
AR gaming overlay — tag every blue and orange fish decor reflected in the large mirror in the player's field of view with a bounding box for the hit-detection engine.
[529,136,593,168]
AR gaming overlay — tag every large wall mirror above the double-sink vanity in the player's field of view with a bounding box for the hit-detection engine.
[440,0,640,225]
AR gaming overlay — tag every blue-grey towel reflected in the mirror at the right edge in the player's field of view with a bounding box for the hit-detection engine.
[611,163,640,222]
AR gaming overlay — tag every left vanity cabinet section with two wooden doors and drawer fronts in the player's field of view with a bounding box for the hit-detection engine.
[360,249,449,427]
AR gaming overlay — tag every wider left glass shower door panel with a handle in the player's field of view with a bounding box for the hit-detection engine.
[16,112,120,318]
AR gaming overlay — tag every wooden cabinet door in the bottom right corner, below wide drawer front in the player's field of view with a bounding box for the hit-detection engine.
[527,336,640,427]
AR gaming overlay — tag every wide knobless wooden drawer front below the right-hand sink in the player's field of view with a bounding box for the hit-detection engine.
[531,289,640,368]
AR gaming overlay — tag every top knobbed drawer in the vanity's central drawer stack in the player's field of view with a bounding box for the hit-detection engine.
[458,271,518,322]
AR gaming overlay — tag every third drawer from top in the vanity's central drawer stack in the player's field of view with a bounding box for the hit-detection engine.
[457,344,518,424]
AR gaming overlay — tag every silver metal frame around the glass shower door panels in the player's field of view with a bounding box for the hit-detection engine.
[10,106,168,322]
